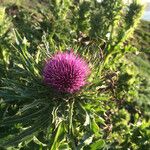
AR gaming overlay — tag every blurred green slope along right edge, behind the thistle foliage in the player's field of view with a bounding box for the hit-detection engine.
[130,20,150,119]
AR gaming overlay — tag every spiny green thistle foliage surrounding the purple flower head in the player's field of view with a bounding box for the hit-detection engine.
[0,0,150,150]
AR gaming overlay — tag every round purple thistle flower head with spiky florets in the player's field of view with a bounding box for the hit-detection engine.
[43,52,90,93]
